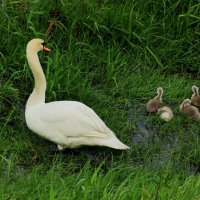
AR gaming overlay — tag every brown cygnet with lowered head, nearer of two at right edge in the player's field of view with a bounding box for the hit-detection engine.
[180,99,200,122]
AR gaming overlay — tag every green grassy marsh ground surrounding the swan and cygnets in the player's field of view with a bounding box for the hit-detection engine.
[0,0,200,200]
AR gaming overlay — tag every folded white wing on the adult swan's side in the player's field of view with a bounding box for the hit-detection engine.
[37,101,111,138]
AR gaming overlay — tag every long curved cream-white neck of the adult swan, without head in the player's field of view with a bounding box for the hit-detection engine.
[26,49,46,106]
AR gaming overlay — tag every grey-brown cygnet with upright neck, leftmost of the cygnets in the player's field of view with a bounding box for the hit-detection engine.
[146,87,163,112]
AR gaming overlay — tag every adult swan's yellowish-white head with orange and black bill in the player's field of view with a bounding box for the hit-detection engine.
[27,38,50,52]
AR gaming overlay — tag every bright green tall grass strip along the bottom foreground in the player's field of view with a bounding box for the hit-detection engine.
[0,159,200,200]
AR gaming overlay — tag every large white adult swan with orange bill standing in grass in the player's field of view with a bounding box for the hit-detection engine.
[25,39,129,150]
